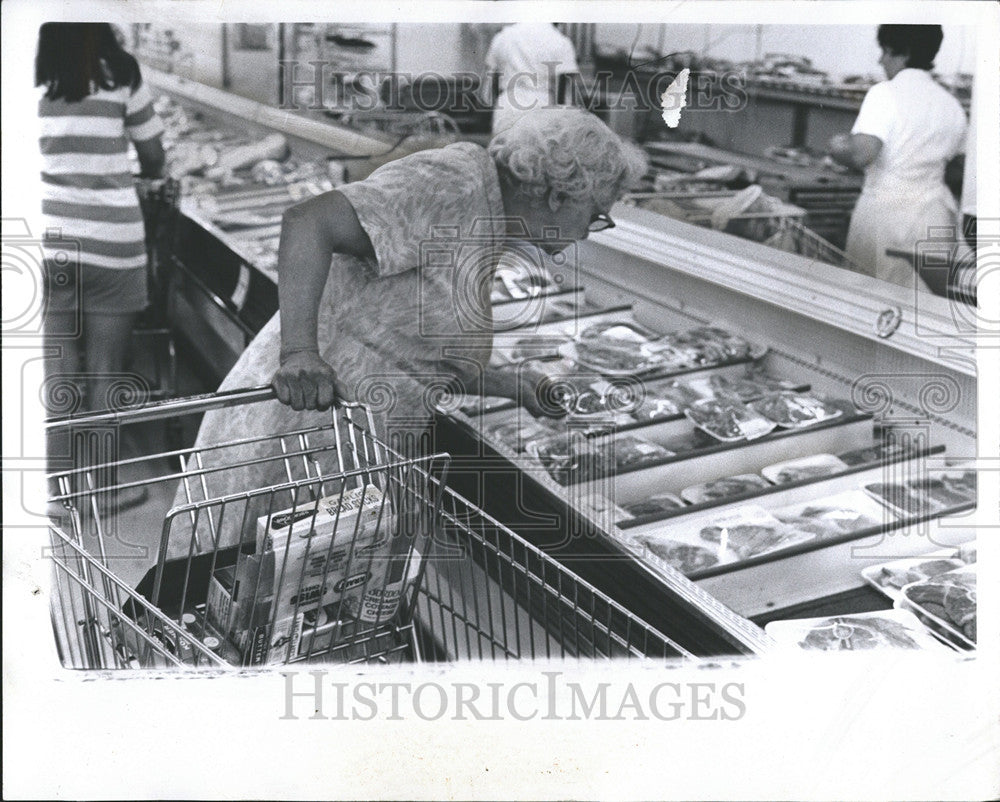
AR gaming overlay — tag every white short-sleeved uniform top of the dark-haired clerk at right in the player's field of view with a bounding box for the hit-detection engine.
[851,68,966,192]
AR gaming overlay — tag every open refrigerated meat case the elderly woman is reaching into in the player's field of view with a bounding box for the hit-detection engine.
[438,204,976,653]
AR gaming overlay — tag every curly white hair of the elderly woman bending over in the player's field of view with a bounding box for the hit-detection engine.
[489,109,647,208]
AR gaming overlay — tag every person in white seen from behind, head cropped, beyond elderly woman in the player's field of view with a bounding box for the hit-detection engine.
[486,22,580,134]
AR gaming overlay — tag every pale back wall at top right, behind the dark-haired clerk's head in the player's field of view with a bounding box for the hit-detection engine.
[594,22,976,78]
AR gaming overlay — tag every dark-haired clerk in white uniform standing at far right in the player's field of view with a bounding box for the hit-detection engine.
[829,25,966,289]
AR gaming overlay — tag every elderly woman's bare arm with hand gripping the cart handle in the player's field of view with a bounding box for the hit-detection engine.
[271,190,375,410]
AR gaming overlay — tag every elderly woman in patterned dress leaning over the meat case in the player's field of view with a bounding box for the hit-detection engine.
[176,109,645,552]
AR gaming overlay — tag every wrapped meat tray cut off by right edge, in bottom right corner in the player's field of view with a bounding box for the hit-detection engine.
[897,566,977,648]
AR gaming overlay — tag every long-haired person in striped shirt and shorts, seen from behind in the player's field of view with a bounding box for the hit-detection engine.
[35,22,164,418]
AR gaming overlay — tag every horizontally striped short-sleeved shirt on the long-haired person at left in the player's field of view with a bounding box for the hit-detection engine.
[38,79,163,269]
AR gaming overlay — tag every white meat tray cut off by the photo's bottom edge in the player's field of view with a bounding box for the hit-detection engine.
[764,610,946,652]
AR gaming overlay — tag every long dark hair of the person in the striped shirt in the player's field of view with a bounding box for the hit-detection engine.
[35,22,142,103]
